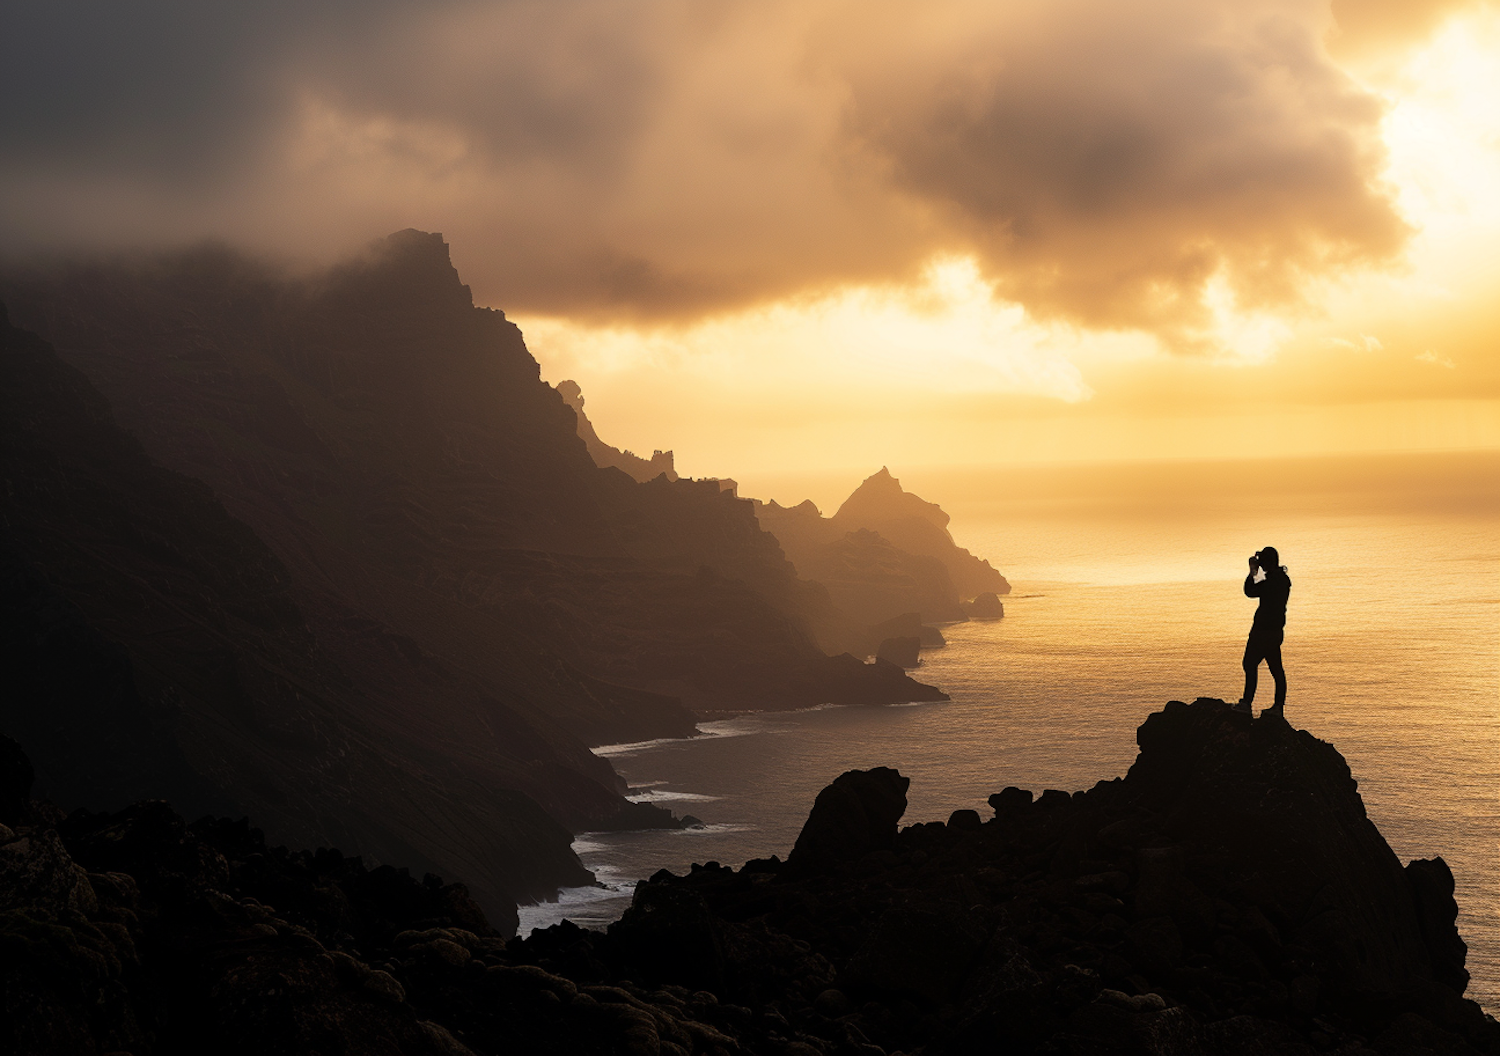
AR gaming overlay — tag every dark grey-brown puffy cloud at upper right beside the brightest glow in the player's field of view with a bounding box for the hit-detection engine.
[851,0,1409,339]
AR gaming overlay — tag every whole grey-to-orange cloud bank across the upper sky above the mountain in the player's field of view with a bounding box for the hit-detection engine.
[0,0,1409,347]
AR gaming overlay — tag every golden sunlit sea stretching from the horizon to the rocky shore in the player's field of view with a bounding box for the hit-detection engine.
[521,455,1500,1011]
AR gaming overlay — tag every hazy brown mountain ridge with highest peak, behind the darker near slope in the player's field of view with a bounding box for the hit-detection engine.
[3,231,930,726]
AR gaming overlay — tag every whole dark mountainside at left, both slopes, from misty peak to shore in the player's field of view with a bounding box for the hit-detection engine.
[0,231,942,926]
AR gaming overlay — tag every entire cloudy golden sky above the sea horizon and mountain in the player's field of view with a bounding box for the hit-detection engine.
[0,0,1500,477]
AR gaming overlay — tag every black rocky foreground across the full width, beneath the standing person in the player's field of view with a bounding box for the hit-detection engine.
[0,699,1500,1056]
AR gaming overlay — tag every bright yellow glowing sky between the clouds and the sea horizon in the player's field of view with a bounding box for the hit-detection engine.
[518,9,1500,473]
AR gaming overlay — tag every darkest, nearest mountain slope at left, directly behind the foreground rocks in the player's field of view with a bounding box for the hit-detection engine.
[0,303,609,921]
